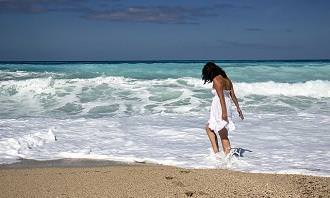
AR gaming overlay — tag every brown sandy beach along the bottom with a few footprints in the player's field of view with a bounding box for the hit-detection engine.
[0,160,330,198]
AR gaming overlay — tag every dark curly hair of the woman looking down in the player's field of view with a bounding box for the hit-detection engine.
[202,62,228,84]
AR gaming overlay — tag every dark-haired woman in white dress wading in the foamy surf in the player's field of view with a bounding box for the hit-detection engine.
[202,62,244,155]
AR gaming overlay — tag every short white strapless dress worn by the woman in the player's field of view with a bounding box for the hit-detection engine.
[208,89,235,132]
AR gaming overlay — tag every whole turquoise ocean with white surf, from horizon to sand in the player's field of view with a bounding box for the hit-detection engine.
[0,60,330,177]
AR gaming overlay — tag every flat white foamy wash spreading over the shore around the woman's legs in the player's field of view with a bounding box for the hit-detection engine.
[0,112,330,176]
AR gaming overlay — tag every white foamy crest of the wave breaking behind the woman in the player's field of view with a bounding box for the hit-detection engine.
[0,76,330,98]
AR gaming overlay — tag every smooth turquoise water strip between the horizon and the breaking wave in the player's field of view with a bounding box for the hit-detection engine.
[0,61,330,83]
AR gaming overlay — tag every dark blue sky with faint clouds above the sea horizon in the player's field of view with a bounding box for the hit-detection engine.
[0,0,330,61]
